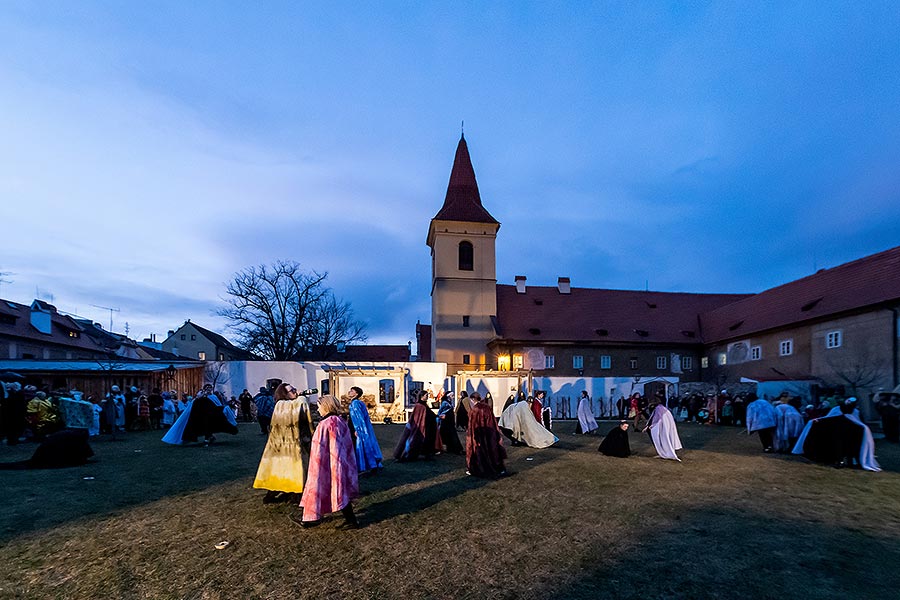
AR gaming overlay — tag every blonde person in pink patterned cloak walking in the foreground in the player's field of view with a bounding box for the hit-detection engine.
[291,396,359,529]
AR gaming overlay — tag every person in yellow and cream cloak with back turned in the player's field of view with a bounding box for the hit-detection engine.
[253,383,313,504]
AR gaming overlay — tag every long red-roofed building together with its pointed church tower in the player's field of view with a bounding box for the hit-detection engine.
[426,137,900,406]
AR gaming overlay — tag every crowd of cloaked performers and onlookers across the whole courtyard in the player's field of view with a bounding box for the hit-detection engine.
[0,372,900,528]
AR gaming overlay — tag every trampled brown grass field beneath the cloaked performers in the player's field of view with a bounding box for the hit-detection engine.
[0,423,900,600]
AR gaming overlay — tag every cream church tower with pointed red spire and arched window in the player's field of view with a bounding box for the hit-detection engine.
[426,135,500,374]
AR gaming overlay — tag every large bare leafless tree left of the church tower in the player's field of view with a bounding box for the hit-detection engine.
[218,260,366,360]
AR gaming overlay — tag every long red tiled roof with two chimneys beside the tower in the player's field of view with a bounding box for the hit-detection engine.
[497,285,747,344]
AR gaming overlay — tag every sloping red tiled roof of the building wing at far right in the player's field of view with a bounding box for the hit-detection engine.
[701,246,900,342]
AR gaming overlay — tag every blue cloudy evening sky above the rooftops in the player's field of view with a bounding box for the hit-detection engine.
[0,0,900,343]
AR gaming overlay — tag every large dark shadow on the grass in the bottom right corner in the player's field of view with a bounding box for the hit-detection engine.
[529,506,900,600]
